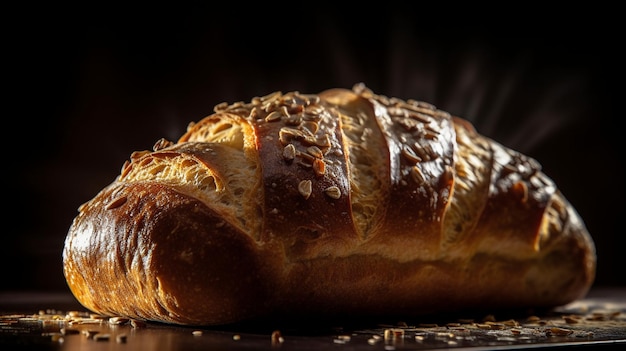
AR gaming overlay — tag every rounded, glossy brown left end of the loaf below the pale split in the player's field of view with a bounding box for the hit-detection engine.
[64,183,271,324]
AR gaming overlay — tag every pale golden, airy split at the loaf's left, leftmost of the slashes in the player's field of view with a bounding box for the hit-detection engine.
[119,114,262,238]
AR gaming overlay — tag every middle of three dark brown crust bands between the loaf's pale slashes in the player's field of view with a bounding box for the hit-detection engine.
[346,84,455,262]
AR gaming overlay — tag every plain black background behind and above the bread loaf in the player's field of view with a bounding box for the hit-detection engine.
[0,3,626,291]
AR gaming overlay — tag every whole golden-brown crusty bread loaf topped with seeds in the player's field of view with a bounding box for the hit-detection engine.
[63,84,596,325]
